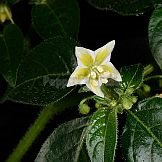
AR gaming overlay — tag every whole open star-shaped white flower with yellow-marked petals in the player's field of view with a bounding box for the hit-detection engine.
[67,40,122,97]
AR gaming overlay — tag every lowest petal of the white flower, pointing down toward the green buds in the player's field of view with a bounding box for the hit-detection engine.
[86,79,104,97]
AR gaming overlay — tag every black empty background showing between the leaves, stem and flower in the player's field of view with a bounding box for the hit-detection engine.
[0,0,153,162]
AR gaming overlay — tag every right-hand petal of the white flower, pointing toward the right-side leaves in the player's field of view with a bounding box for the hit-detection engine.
[103,62,122,82]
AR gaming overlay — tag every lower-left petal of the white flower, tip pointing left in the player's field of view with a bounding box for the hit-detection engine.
[67,66,89,87]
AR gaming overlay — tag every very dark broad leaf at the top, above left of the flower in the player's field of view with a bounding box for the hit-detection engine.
[32,0,80,38]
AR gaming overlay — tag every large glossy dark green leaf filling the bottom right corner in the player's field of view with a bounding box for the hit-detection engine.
[122,97,162,162]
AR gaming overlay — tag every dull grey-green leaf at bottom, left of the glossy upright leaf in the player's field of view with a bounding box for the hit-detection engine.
[35,117,89,162]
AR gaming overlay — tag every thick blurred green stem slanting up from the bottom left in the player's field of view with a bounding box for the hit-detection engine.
[6,93,79,162]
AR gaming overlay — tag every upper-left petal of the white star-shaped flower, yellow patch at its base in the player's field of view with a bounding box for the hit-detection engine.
[75,47,94,67]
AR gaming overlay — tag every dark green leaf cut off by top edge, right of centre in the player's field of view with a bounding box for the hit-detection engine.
[88,0,161,15]
